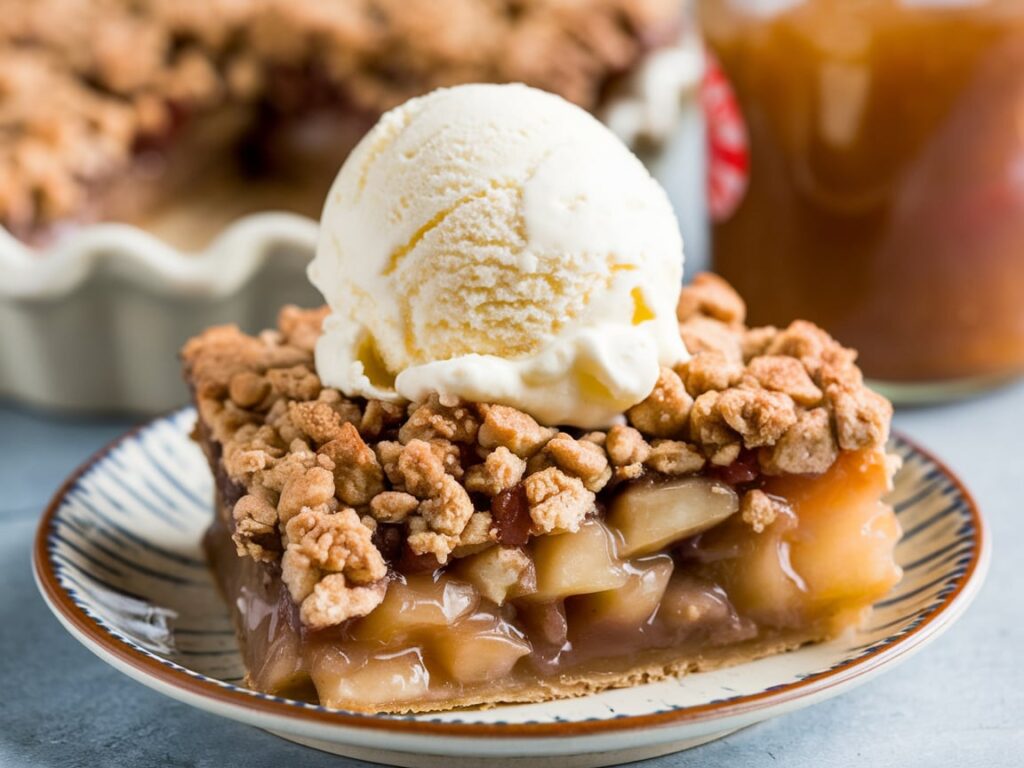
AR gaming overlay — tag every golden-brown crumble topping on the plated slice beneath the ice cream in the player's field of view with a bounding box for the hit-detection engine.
[182,275,892,628]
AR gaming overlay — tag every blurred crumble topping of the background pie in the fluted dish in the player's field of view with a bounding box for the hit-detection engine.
[0,0,680,234]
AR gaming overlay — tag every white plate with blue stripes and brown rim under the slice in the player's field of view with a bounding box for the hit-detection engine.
[33,409,989,768]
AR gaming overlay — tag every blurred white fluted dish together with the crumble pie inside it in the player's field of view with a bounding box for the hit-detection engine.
[0,0,703,413]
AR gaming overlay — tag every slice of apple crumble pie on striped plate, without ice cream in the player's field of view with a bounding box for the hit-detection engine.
[183,274,900,712]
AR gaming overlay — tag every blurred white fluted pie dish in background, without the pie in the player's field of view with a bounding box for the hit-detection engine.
[0,37,705,414]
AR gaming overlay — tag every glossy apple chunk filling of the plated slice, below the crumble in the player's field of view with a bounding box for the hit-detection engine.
[207,450,900,712]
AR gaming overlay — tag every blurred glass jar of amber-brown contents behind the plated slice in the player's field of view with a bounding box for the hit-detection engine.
[699,0,1024,401]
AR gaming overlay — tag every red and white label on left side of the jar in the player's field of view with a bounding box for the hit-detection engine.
[700,52,751,221]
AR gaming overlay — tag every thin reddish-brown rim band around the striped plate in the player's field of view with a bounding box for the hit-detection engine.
[33,411,988,738]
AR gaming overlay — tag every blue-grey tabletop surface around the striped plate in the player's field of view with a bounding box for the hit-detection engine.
[0,386,1024,768]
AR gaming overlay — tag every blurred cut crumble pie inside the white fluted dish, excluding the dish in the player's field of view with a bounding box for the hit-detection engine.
[0,0,681,243]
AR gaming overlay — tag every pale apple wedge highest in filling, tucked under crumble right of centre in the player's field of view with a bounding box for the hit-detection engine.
[607,477,739,557]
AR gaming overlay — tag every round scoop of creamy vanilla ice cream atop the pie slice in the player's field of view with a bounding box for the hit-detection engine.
[309,85,686,428]
